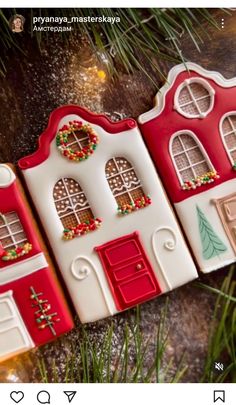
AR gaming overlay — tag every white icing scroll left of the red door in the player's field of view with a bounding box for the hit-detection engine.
[71,256,113,315]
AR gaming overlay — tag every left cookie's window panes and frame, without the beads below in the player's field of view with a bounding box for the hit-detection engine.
[0,211,28,250]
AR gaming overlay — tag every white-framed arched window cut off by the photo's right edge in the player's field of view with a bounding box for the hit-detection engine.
[220,111,236,165]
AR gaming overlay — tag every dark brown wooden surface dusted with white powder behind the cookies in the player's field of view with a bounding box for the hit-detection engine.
[0,11,236,382]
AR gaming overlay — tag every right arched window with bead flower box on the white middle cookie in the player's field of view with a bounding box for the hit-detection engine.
[105,157,151,214]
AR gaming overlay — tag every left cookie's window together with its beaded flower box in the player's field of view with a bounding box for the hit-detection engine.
[0,212,32,261]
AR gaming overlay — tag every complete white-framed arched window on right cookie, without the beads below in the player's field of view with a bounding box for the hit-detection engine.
[169,130,214,185]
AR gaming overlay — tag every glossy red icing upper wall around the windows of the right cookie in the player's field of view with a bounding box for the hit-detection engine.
[140,71,236,203]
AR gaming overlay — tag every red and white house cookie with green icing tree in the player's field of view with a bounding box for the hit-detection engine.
[139,63,236,273]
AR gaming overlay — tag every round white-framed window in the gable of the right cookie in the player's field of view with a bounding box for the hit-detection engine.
[174,77,215,118]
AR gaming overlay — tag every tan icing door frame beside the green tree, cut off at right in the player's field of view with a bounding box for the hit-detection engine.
[212,192,236,254]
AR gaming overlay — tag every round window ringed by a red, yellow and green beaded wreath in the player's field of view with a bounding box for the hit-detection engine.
[56,120,99,162]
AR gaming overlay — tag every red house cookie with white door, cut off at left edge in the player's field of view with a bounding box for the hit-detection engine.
[0,164,73,361]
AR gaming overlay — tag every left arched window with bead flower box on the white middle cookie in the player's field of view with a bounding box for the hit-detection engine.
[53,178,101,240]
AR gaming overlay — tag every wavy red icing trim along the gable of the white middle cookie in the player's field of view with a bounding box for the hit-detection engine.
[18,105,137,170]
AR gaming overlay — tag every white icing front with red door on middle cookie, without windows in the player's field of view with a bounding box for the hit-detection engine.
[19,107,197,323]
